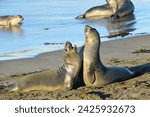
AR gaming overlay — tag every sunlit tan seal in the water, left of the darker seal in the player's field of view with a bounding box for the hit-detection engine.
[75,0,117,19]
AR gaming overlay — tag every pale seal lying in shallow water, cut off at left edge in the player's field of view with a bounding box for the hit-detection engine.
[0,15,24,27]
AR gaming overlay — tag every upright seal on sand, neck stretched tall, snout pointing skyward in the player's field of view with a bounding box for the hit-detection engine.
[83,26,135,86]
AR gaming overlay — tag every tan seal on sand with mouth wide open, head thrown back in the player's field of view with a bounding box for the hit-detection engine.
[8,41,81,92]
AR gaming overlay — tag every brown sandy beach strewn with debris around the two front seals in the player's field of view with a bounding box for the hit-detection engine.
[0,35,150,100]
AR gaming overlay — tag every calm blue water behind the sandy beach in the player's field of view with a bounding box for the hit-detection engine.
[0,0,150,60]
